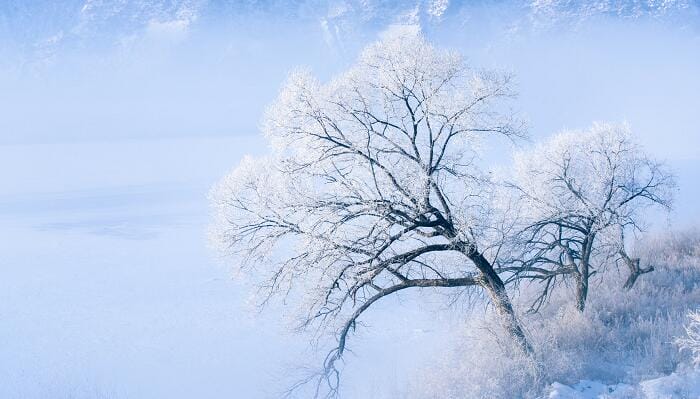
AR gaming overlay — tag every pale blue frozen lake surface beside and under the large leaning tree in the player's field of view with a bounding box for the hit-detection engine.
[0,138,450,399]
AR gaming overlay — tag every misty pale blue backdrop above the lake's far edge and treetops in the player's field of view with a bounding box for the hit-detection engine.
[0,0,700,219]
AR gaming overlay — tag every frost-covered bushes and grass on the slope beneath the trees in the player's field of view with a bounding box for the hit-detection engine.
[412,230,700,399]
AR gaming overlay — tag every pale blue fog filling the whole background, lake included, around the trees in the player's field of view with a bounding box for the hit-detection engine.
[0,0,700,398]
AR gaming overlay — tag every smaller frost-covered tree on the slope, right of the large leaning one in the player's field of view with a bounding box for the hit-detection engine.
[511,123,674,311]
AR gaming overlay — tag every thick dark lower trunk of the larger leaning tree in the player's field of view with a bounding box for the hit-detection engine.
[467,251,534,356]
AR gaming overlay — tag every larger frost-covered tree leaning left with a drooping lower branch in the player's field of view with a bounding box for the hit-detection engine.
[212,34,531,392]
